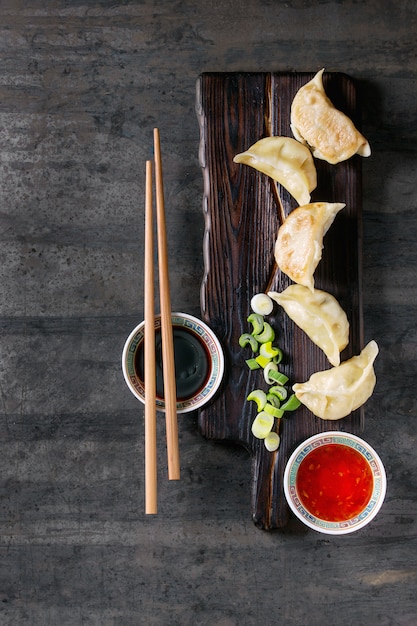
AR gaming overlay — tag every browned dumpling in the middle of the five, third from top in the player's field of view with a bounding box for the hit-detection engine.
[275,202,346,291]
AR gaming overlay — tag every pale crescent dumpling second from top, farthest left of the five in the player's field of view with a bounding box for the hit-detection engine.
[233,137,317,204]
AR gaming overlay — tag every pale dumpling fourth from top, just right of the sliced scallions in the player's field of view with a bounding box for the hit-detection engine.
[268,285,349,366]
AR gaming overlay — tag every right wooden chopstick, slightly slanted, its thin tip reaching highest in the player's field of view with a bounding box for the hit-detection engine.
[154,128,180,480]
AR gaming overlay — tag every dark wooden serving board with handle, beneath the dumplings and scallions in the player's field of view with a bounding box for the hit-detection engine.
[197,73,363,529]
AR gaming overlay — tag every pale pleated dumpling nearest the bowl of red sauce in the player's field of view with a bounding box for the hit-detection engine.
[293,341,378,420]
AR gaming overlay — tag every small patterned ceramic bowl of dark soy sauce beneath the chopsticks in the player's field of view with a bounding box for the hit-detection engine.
[122,313,224,413]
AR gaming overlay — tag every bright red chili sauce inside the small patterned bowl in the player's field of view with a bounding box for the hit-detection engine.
[296,444,373,522]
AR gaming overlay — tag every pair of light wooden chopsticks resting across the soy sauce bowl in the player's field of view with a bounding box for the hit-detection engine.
[144,128,180,514]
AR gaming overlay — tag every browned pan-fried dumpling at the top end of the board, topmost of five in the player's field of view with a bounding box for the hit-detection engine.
[291,69,371,164]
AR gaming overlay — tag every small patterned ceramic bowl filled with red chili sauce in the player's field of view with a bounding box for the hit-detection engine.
[284,431,387,535]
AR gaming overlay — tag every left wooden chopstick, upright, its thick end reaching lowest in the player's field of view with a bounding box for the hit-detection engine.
[145,161,158,515]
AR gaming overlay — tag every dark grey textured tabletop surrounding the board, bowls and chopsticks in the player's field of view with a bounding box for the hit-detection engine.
[0,0,417,626]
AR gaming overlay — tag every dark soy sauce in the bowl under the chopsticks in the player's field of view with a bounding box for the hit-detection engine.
[135,326,209,402]
